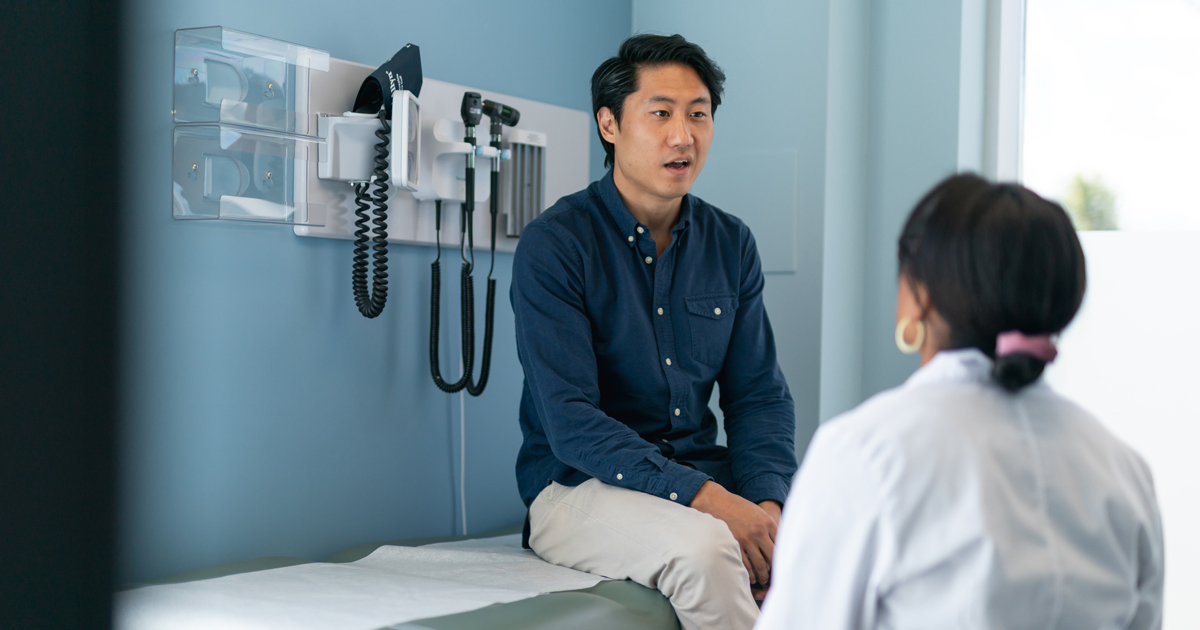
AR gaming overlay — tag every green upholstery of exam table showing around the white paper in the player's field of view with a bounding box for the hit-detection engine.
[119,526,679,630]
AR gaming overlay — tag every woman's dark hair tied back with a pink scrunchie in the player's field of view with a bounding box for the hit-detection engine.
[899,174,1087,391]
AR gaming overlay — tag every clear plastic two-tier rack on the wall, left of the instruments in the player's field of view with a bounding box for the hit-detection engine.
[172,26,329,227]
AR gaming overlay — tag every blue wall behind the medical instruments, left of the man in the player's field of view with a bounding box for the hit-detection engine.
[119,0,631,582]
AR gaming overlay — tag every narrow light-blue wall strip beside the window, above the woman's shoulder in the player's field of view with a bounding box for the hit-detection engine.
[863,0,984,396]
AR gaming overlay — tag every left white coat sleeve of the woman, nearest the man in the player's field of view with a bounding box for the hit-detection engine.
[755,426,888,630]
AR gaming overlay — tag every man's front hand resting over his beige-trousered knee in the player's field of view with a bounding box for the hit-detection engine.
[691,481,779,592]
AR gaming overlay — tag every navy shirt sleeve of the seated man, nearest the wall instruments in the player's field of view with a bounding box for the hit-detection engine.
[512,222,712,505]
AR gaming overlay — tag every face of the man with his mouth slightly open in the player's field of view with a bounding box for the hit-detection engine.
[596,64,713,200]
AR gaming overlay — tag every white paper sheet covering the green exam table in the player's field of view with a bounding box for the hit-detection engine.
[114,535,605,630]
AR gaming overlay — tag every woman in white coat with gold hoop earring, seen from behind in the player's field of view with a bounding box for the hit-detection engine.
[757,175,1163,630]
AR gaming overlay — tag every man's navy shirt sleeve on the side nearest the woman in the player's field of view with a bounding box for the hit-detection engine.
[718,227,796,503]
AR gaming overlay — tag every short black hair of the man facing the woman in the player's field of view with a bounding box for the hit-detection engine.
[592,35,725,168]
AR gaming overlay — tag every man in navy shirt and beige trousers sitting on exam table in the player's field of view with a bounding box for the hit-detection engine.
[511,35,796,630]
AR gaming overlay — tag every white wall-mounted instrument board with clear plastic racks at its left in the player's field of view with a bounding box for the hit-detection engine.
[172,26,593,241]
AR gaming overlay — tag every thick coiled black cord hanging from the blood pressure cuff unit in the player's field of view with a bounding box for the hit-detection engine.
[352,108,391,318]
